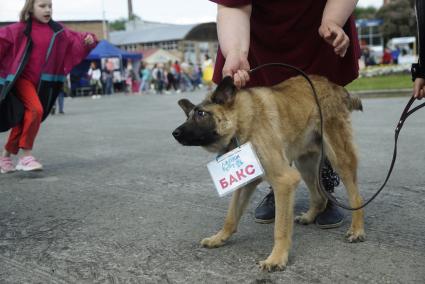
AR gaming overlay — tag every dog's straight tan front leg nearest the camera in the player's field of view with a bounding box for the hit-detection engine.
[260,165,301,271]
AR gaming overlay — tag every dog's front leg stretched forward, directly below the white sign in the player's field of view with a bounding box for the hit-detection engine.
[201,180,261,248]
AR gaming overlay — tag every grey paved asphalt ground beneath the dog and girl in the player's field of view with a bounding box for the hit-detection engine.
[0,89,425,283]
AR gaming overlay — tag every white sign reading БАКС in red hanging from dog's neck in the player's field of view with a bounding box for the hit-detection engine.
[207,142,264,197]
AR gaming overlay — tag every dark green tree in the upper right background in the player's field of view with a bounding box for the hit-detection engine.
[376,0,416,43]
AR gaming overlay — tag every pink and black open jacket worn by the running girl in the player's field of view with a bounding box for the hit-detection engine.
[0,20,97,132]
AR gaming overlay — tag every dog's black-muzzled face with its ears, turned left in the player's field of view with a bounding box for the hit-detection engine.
[173,77,236,147]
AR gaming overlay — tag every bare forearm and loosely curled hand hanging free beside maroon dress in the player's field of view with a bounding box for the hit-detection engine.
[319,0,358,57]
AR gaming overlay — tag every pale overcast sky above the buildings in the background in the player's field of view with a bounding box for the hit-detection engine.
[0,0,383,24]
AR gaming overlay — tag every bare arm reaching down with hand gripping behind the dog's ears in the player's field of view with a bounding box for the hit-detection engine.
[217,5,252,88]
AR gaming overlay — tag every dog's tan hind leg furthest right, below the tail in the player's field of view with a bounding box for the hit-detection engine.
[327,121,365,242]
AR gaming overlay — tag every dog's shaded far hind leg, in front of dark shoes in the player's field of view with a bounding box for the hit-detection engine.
[295,152,326,225]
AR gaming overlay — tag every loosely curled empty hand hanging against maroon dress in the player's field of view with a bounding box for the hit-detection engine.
[319,21,350,57]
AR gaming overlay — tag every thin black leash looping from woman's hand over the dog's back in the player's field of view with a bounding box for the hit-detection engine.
[248,63,425,211]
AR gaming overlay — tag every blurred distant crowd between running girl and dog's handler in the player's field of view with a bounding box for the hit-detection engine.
[81,54,214,97]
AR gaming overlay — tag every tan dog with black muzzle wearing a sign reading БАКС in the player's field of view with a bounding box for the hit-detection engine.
[172,75,365,271]
